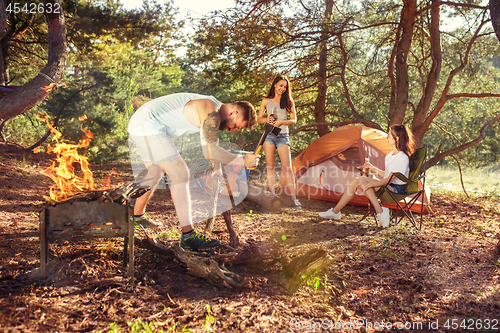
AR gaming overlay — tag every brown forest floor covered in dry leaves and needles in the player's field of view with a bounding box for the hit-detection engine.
[0,141,500,332]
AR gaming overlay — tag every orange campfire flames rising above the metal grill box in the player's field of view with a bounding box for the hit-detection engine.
[39,116,94,201]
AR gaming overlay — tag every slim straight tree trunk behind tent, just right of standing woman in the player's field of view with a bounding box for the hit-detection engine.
[314,0,333,136]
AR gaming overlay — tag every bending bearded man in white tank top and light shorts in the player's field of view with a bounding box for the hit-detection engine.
[128,93,259,251]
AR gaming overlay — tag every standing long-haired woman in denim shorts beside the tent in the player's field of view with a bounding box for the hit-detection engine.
[257,75,302,208]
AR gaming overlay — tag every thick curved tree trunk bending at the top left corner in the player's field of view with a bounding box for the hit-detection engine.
[0,0,67,121]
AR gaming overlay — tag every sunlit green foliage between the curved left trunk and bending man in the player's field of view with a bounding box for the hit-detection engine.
[4,0,183,162]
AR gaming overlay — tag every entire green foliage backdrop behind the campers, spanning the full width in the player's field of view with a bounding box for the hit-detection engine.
[3,0,500,166]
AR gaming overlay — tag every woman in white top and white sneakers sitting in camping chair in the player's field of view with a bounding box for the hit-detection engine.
[319,125,416,228]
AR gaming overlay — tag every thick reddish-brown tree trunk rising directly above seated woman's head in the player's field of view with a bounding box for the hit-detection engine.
[388,0,417,126]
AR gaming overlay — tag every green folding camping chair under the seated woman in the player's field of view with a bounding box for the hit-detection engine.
[360,146,427,230]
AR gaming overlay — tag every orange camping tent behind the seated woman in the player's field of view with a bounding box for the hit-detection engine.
[281,125,430,213]
